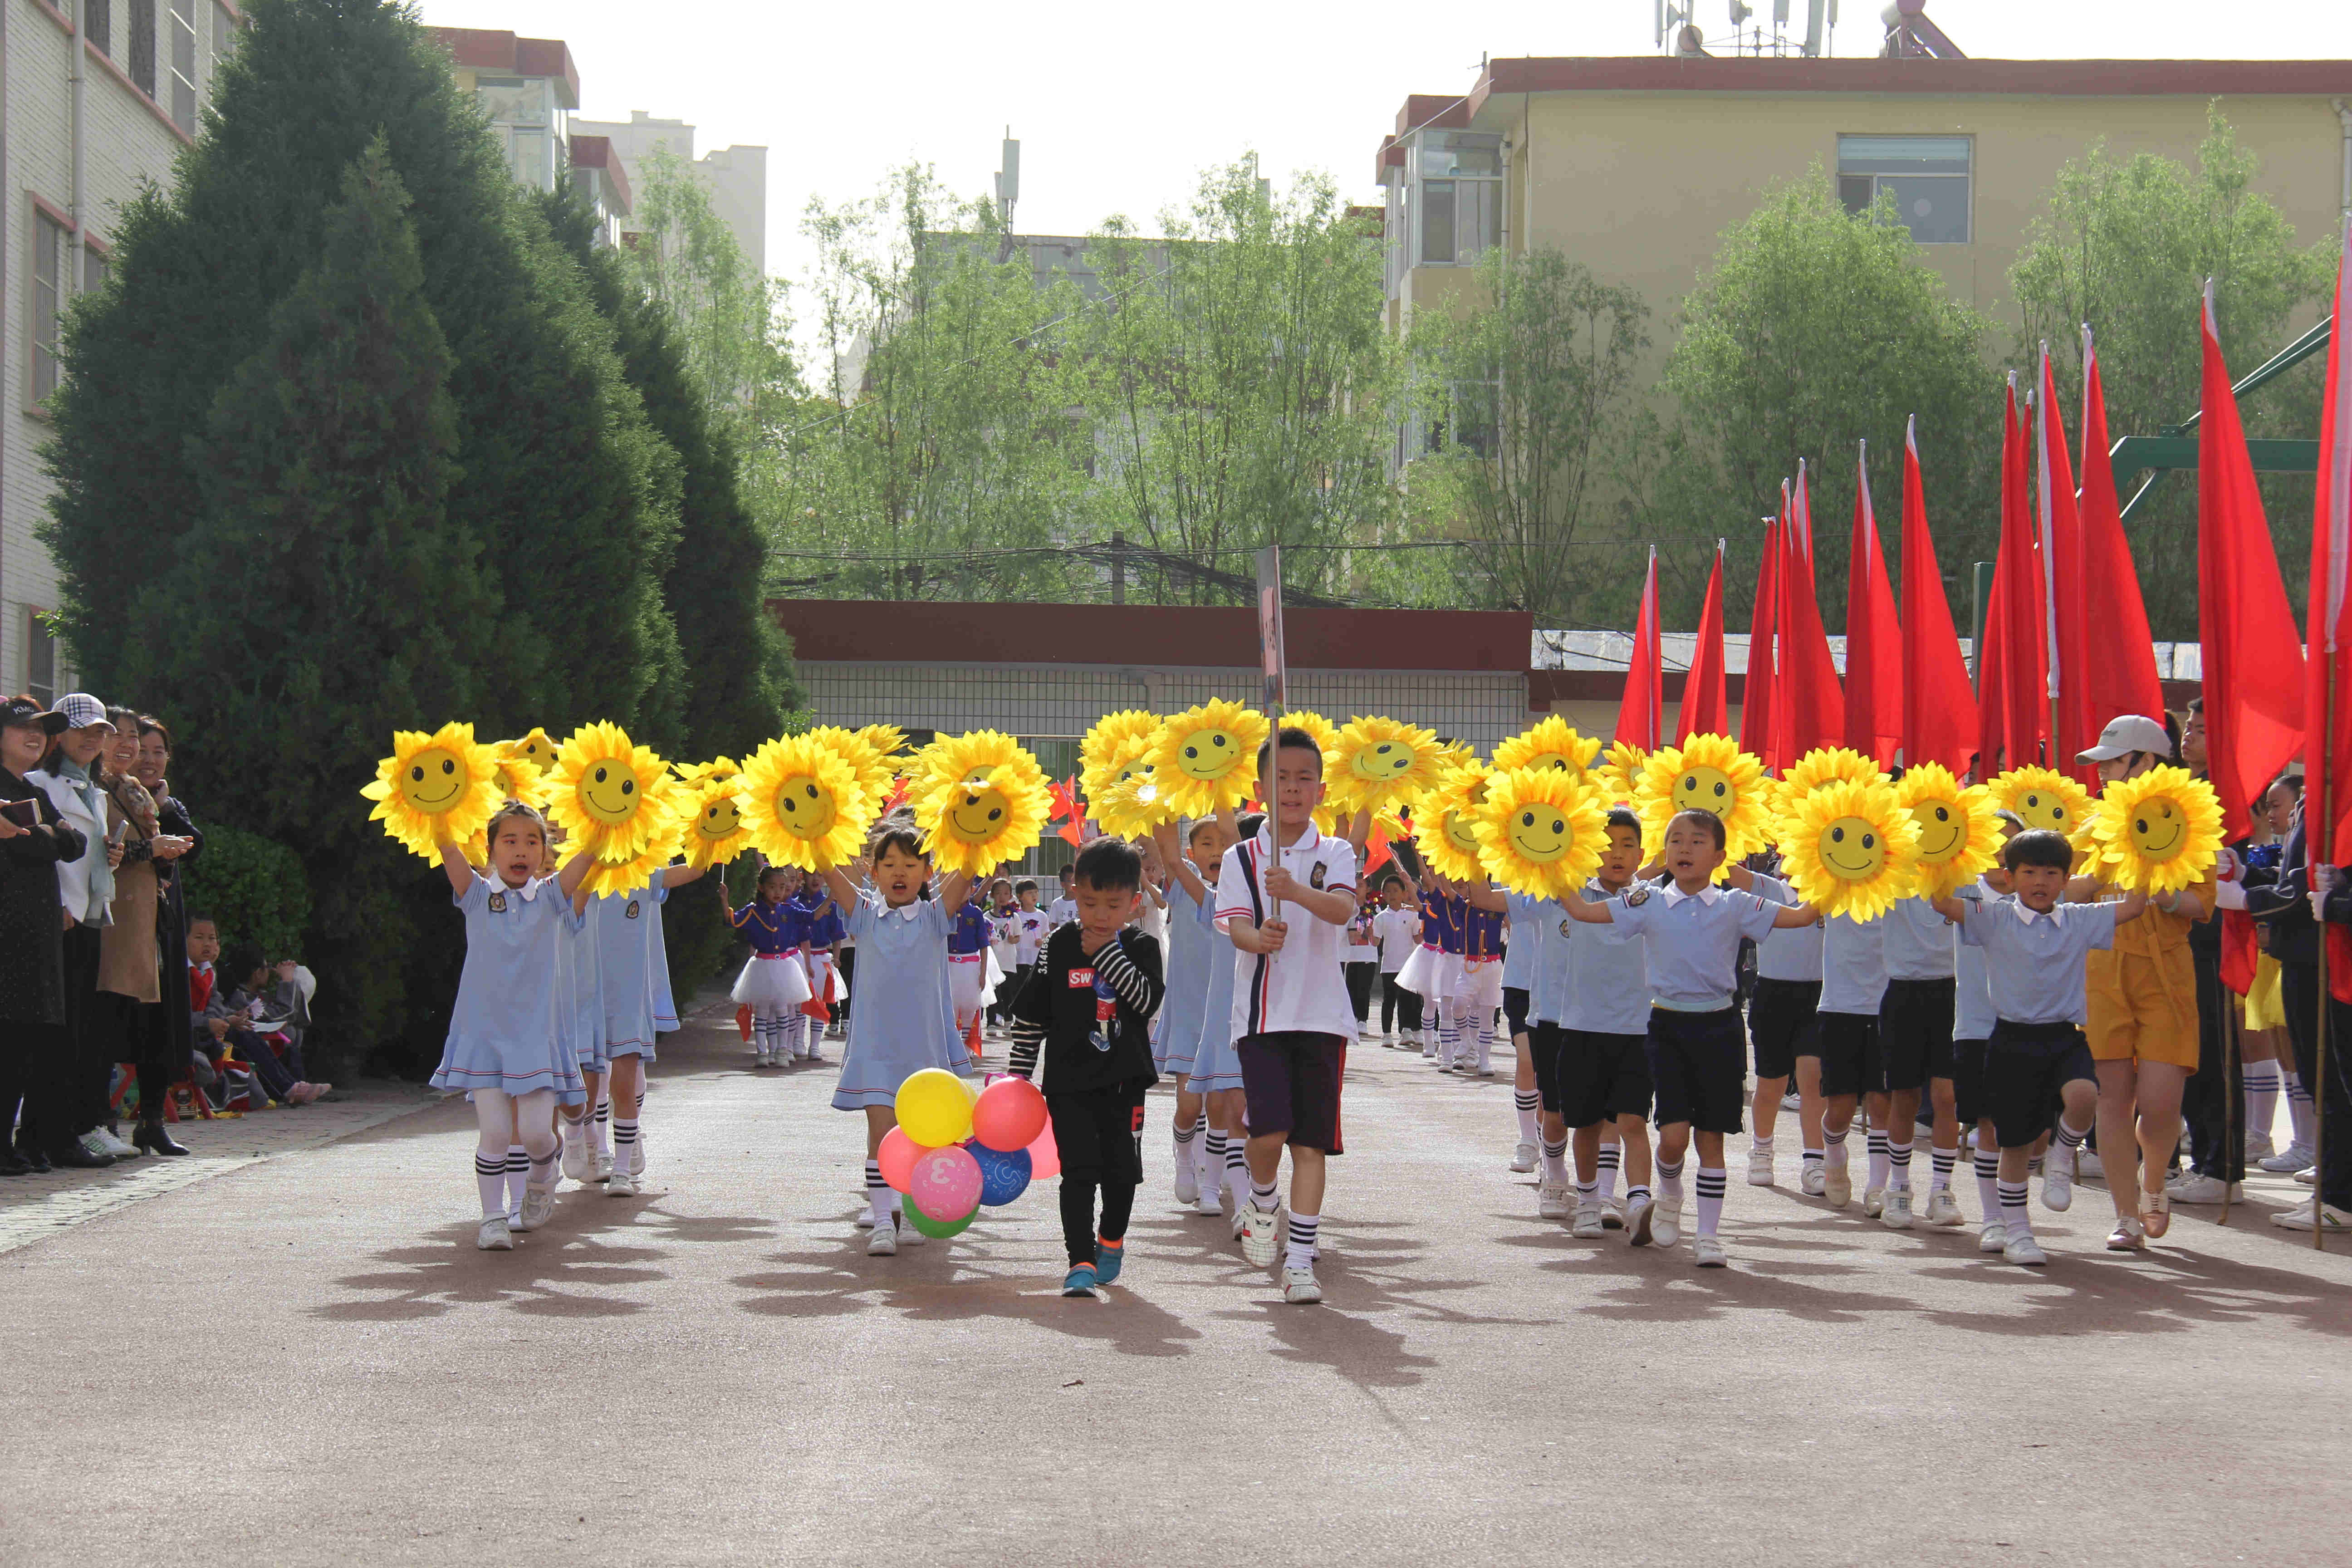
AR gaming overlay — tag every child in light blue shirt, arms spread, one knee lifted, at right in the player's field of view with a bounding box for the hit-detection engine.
[1936,828,2147,1269]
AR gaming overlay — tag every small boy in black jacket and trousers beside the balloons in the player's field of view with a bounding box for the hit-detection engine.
[1011,839,1166,1295]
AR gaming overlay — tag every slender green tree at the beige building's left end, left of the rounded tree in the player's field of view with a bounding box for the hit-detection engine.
[1409,249,1649,625]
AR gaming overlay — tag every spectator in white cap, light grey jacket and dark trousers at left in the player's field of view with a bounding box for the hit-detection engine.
[26,691,129,1171]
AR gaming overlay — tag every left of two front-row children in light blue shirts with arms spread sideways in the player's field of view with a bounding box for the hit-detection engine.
[1567,811,1818,1269]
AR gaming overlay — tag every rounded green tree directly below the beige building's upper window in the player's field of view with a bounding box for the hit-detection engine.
[1625,167,2002,627]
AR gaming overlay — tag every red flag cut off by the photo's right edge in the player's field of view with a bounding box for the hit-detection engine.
[2295,221,2352,1001]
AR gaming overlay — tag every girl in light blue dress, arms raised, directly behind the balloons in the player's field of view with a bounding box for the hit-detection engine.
[823,816,974,1258]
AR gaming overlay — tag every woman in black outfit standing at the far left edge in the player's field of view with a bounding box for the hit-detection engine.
[0,696,87,1176]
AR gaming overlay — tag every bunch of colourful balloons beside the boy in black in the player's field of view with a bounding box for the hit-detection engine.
[880,1067,1061,1239]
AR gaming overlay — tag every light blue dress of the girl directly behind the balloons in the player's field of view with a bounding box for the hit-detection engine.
[833,891,971,1110]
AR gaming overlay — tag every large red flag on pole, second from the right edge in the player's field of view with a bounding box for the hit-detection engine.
[2197,280,2305,842]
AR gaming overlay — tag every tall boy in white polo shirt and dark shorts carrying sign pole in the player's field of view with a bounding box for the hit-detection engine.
[1216,726,1355,1303]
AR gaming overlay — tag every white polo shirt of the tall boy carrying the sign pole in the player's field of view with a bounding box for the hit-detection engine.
[1216,823,1355,1039]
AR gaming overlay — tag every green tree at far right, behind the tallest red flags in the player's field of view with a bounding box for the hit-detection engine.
[2009,103,2336,637]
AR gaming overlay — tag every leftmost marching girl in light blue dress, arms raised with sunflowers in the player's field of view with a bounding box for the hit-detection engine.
[433,802,593,1251]
